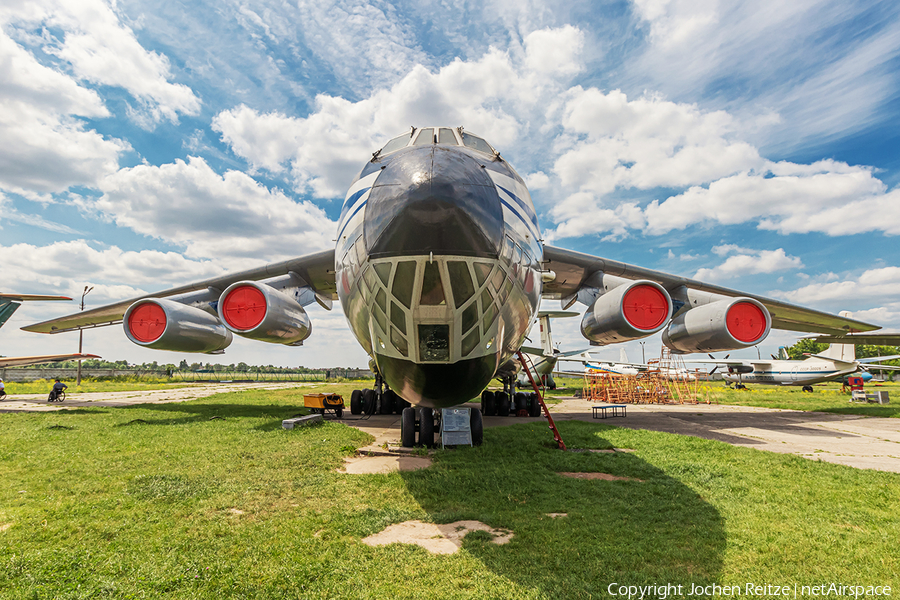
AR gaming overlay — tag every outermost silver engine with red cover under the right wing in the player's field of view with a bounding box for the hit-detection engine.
[662,298,772,354]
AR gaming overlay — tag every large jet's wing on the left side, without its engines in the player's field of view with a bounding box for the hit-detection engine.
[22,250,337,333]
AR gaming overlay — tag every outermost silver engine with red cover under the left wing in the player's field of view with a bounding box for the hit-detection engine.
[122,298,233,353]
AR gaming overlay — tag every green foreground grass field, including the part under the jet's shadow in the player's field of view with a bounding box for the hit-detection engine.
[0,386,900,599]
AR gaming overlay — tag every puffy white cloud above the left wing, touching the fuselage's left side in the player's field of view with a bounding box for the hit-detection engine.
[90,157,336,263]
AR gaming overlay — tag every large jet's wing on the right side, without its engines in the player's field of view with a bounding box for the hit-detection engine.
[543,245,880,344]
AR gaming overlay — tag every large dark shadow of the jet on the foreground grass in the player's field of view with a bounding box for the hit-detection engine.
[402,422,725,598]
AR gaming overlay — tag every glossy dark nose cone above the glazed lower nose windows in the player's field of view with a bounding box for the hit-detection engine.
[364,145,503,258]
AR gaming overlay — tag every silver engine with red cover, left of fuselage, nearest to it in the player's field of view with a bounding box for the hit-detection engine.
[219,281,312,345]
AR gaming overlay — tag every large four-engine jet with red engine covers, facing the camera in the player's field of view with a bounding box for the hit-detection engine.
[24,127,878,444]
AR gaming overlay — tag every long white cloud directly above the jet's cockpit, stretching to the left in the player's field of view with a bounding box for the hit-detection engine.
[213,37,574,198]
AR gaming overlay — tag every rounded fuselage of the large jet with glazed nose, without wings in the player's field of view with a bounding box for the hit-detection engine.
[335,128,543,408]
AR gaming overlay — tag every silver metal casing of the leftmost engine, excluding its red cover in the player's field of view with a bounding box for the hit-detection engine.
[122,298,233,354]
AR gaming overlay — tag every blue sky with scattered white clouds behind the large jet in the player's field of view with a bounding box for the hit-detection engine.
[0,0,900,366]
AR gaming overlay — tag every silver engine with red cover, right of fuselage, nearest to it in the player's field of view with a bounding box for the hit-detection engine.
[581,280,672,346]
